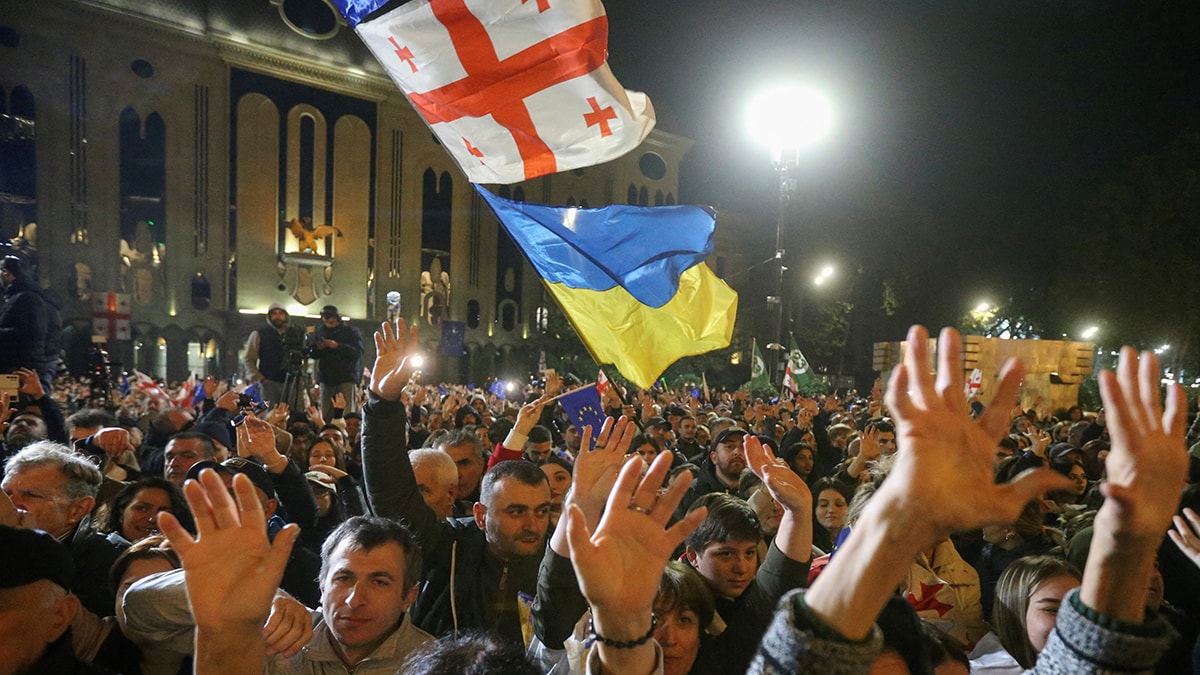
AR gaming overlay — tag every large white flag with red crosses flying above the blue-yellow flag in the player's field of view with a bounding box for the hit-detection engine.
[350,0,654,184]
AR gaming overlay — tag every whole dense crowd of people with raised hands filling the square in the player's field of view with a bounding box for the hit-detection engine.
[0,317,1200,675]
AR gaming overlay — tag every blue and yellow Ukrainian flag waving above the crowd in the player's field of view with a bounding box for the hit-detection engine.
[475,185,738,388]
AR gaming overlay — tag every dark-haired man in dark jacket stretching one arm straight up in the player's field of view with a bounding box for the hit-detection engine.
[362,322,550,643]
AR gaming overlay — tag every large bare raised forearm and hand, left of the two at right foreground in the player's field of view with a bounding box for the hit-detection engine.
[796,327,1066,640]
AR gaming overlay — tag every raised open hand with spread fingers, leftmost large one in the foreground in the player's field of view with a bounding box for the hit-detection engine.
[158,470,300,673]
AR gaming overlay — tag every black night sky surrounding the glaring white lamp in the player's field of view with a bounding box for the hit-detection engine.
[605,0,1200,339]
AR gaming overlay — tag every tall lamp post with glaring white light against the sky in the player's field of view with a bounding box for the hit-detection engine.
[748,86,833,382]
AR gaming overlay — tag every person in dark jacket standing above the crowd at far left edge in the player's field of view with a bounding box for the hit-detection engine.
[0,256,46,372]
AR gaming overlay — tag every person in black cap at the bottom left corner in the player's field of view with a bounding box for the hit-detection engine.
[0,523,112,673]
